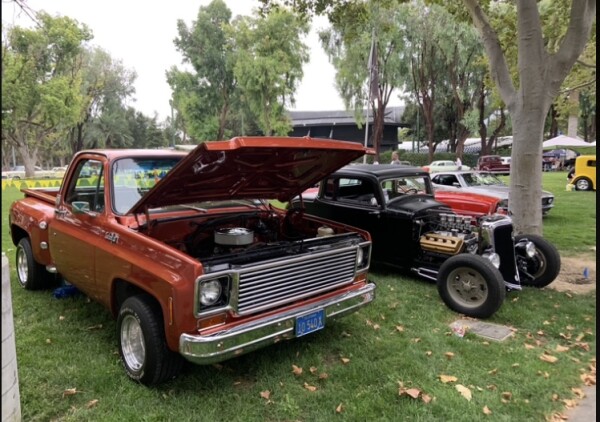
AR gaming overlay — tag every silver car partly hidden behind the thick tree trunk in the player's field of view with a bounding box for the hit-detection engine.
[431,171,554,215]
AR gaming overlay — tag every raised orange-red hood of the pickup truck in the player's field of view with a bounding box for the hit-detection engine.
[130,137,373,213]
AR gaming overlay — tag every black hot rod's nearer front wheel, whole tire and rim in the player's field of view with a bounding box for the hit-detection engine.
[437,254,506,318]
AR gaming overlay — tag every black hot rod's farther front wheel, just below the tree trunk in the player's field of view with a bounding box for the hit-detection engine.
[515,234,560,287]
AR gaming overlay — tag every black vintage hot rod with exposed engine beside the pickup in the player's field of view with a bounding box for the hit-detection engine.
[290,164,560,318]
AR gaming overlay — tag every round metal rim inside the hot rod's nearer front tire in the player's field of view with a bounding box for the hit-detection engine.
[448,267,488,308]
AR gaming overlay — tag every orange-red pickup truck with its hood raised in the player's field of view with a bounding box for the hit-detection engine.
[9,137,375,385]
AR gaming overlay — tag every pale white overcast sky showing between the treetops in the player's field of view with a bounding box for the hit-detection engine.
[2,0,399,121]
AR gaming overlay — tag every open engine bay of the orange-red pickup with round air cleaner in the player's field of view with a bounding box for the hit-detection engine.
[141,209,365,272]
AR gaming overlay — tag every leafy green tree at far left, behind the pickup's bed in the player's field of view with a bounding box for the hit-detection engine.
[2,12,92,176]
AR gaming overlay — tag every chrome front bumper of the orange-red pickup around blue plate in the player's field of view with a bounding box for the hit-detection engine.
[179,283,375,365]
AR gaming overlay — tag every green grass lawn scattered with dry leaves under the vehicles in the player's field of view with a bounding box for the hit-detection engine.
[2,173,596,421]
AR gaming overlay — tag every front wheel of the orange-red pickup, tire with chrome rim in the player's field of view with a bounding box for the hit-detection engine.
[117,295,183,386]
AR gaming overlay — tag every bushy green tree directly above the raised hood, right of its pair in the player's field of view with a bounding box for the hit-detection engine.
[231,9,309,135]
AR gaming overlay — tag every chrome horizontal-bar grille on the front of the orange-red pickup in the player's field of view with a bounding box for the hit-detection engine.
[232,245,358,315]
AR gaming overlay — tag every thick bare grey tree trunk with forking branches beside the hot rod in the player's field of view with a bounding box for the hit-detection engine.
[463,0,596,234]
